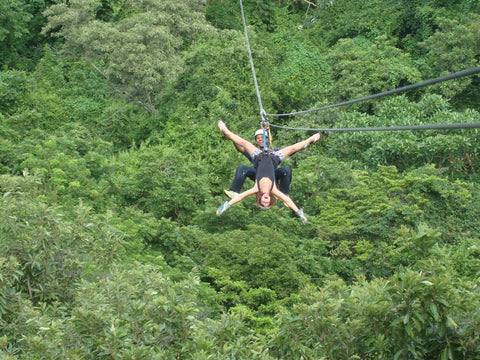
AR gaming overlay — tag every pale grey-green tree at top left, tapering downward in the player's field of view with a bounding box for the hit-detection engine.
[43,0,214,114]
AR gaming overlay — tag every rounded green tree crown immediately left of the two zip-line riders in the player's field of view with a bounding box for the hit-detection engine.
[111,146,212,222]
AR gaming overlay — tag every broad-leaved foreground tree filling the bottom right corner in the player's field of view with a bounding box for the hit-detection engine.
[271,262,480,360]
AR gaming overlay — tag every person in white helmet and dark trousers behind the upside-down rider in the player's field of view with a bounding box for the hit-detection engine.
[224,129,292,199]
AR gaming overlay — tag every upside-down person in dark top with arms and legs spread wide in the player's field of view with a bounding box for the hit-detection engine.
[217,120,321,224]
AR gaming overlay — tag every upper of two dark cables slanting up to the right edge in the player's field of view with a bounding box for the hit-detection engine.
[266,67,480,116]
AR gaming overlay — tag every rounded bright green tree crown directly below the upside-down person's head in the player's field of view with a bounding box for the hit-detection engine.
[196,225,307,306]
